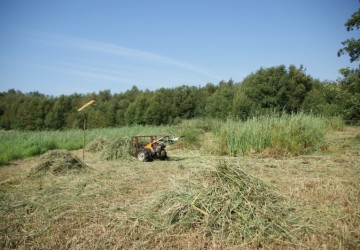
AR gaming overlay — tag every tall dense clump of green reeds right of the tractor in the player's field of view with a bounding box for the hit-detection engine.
[218,114,338,156]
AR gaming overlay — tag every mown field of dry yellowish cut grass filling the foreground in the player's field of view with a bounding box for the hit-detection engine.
[0,124,360,249]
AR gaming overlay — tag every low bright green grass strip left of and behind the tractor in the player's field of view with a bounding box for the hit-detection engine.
[0,125,174,165]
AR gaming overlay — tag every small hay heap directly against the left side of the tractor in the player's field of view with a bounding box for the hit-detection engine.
[100,138,131,160]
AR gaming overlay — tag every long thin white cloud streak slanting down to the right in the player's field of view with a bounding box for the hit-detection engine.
[40,33,219,80]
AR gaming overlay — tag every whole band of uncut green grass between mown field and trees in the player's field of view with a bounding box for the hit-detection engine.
[0,114,344,165]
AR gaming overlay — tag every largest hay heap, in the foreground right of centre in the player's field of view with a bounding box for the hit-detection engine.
[144,162,304,247]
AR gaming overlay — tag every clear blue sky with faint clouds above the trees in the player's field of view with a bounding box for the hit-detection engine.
[0,0,360,96]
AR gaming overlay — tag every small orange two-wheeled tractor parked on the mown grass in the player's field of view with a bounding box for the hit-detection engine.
[131,135,182,162]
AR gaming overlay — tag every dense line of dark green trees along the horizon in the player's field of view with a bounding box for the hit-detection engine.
[0,65,360,130]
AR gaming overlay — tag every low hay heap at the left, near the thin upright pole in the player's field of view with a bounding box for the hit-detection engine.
[29,150,89,176]
